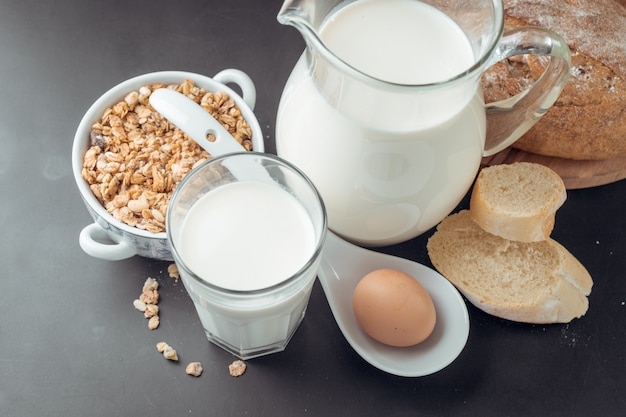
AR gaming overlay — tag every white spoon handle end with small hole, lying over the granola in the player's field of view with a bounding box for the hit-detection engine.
[150,88,245,156]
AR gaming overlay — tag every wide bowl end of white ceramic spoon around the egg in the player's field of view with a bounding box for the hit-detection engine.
[318,231,469,377]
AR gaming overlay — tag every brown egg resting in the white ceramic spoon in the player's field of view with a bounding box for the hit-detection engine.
[352,269,437,347]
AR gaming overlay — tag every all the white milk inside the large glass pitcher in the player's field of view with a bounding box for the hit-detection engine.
[276,0,486,245]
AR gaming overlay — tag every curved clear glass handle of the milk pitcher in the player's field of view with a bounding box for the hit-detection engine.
[483,27,571,156]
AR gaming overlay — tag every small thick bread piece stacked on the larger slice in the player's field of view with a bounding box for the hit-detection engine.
[470,162,567,242]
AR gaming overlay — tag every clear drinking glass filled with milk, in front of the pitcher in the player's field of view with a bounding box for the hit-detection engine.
[166,152,326,359]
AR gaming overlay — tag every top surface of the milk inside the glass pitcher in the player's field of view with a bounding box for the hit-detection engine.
[321,0,474,84]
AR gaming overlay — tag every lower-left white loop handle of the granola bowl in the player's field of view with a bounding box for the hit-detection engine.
[78,223,137,261]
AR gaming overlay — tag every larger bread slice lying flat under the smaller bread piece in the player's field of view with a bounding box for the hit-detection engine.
[427,210,593,323]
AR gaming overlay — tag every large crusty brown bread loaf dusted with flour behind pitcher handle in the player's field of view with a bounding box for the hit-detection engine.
[483,0,626,160]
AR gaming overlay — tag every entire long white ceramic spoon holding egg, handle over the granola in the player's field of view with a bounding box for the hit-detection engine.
[150,89,469,377]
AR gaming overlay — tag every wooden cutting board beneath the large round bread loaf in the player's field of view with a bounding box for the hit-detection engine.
[482,148,626,190]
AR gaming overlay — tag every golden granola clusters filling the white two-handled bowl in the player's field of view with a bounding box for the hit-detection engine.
[82,80,252,233]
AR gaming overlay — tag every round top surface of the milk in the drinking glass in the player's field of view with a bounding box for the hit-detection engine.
[180,182,316,291]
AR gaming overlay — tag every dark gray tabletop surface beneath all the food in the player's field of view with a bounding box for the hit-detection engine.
[0,0,626,417]
